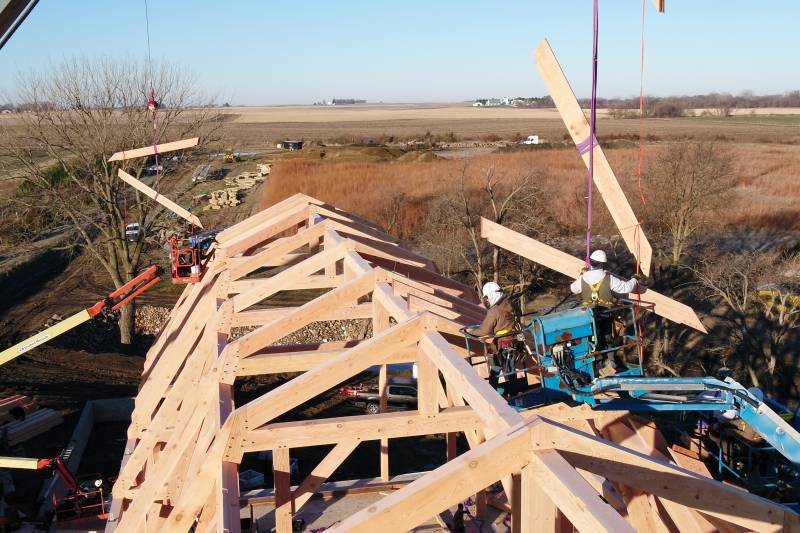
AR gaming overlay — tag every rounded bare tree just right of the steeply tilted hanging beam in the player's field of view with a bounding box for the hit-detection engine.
[645,143,733,265]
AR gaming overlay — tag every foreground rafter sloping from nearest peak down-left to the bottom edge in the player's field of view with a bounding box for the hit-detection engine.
[329,419,540,533]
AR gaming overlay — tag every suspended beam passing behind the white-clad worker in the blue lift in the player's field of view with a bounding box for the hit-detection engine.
[481,218,708,333]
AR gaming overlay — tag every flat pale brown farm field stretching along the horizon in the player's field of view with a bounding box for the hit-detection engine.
[216,104,800,150]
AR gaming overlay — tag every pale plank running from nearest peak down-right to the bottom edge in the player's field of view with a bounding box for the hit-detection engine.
[529,450,635,533]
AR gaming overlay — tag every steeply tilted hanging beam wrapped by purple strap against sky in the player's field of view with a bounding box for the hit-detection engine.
[534,39,653,274]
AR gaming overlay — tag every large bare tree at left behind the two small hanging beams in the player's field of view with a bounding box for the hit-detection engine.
[0,57,218,344]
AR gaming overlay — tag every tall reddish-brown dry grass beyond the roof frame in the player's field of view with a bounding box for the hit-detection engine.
[260,143,800,239]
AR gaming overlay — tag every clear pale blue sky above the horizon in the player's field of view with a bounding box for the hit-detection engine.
[0,0,800,105]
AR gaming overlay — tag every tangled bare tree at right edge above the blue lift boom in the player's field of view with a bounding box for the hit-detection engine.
[695,252,800,397]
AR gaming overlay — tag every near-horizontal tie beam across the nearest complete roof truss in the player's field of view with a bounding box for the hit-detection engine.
[244,406,483,452]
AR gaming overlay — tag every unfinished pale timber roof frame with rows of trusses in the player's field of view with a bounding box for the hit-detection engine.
[106,195,800,533]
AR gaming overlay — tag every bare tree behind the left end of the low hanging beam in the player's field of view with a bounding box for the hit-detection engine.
[421,164,544,288]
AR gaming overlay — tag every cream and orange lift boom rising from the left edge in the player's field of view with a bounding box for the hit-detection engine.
[0,265,161,365]
